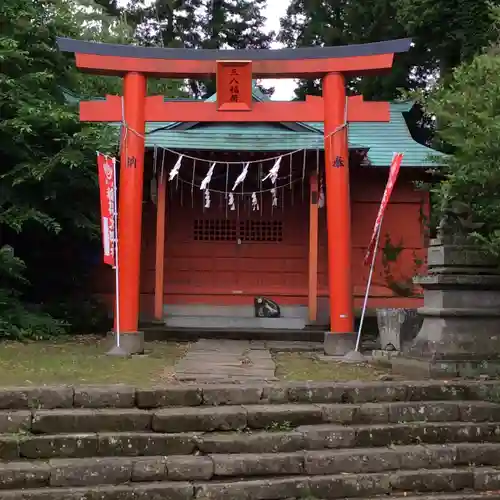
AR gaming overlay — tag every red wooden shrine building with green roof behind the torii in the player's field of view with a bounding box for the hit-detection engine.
[90,87,442,331]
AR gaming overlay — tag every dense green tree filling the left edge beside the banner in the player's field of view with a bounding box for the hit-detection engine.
[0,0,125,337]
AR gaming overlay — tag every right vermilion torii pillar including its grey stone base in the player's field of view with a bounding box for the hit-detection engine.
[323,73,356,355]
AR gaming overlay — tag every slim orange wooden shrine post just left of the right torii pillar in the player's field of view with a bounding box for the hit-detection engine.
[308,172,319,323]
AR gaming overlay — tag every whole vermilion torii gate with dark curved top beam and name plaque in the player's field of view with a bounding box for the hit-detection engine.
[57,38,411,354]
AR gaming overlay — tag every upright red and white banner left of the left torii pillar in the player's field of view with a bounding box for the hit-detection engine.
[97,153,116,267]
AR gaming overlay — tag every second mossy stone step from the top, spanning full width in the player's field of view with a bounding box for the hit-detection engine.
[20,401,500,434]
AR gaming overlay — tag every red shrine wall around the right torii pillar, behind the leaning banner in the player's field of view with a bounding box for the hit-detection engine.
[318,168,429,308]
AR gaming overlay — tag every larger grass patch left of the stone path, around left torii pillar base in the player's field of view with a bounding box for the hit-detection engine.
[0,336,187,386]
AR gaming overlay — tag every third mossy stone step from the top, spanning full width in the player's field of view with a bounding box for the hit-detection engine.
[0,422,500,460]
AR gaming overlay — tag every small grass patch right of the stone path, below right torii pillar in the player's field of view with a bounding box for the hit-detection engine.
[274,353,388,382]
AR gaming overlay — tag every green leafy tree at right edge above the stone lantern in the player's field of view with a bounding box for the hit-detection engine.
[426,48,500,256]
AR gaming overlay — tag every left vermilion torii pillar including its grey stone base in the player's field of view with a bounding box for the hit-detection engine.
[115,73,146,354]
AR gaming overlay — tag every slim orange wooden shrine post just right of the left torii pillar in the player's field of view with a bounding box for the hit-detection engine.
[154,172,167,321]
